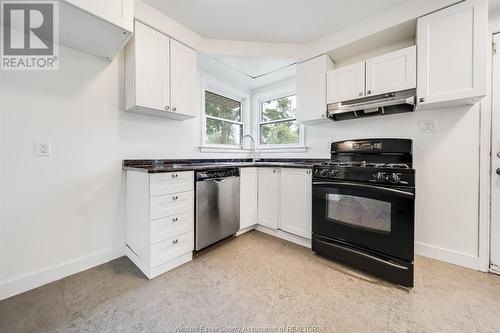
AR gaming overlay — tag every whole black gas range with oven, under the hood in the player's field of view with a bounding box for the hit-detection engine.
[312,139,415,287]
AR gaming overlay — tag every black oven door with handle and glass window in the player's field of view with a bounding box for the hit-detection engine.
[312,180,415,261]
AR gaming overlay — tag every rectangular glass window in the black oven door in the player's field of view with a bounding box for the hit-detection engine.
[327,194,391,233]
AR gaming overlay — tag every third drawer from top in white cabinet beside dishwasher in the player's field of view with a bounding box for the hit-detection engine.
[150,211,194,244]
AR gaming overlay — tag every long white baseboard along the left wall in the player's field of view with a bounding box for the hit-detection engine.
[0,246,125,300]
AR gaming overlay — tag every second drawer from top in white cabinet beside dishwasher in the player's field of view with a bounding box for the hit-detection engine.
[149,191,194,220]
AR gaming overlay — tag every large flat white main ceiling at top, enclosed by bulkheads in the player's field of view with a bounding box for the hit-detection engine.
[144,0,410,44]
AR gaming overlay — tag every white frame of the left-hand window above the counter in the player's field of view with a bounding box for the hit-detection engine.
[200,81,247,150]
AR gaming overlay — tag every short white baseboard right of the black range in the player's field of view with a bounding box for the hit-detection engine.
[415,242,480,270]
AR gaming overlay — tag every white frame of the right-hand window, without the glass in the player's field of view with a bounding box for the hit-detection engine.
[254,88,305,150]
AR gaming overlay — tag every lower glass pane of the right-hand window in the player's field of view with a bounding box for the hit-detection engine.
[260,120,299,145]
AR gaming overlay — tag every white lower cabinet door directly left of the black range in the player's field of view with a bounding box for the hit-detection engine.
[279,169,312,239]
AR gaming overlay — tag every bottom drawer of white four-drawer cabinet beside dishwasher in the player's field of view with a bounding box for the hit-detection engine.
[151,231,194,267]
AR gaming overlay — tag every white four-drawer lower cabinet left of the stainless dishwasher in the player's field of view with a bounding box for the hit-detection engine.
[126,171,194,279]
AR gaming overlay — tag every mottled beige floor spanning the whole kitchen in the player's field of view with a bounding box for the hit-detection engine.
[0,231,500,333]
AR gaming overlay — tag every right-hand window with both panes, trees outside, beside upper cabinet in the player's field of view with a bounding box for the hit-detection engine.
[258,95,302,146]
